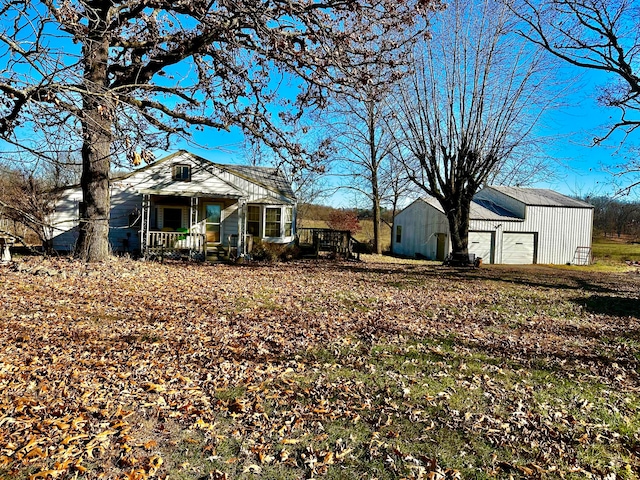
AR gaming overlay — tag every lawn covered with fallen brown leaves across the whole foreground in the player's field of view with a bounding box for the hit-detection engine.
[0,259,640,479]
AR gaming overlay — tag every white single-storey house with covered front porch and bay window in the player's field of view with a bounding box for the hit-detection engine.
[51,151,296,259]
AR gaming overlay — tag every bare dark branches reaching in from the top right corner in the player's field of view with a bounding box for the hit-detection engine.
[507,0,640,194]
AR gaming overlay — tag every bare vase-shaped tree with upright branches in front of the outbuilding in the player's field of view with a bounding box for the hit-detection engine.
[395,0,550,254]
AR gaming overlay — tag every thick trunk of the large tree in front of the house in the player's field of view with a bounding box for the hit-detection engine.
[76,25,112,262]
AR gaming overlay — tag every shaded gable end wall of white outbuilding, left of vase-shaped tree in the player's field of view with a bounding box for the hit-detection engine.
[391,199,449,260]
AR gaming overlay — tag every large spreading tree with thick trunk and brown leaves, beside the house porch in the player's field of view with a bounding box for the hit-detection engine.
[0,0,438,261]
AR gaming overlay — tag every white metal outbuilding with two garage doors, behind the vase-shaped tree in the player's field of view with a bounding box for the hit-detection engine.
[391,186,593,264]
